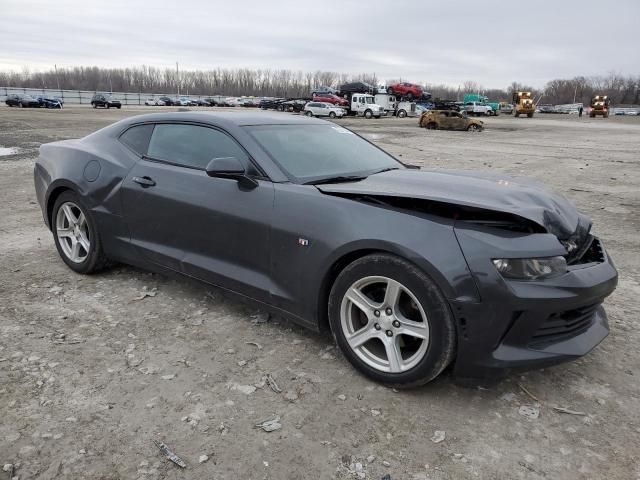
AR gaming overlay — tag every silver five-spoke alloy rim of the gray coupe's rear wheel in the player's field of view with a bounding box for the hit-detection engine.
[56,202,91,263]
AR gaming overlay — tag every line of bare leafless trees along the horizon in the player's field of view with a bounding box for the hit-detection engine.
[0,65,640,105]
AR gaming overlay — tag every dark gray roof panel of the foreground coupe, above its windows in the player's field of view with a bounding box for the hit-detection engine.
[117,112,325,126]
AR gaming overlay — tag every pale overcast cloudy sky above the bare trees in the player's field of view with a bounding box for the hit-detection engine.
[0,0,640,88]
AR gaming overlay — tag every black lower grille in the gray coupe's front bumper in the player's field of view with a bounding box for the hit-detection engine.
[530,303,600,346]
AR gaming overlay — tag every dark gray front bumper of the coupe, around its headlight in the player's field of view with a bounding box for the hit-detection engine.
[451,228,618,381]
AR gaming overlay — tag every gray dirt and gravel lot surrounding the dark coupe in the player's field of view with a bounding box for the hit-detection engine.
[0,107,640,480]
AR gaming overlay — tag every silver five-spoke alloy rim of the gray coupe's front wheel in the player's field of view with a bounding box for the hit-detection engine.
[340,276,429,373]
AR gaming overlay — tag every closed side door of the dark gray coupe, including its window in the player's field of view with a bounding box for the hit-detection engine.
[122,123,274,301]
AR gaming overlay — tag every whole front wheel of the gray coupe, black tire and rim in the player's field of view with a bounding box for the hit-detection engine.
[329,254,456,387]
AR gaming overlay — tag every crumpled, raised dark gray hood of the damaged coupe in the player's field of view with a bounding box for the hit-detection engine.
[317,169,584,239]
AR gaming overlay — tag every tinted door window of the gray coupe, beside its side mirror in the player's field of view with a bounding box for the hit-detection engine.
[147,124,249,169]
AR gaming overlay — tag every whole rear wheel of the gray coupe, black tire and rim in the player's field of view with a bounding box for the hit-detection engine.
[51,191,108,274]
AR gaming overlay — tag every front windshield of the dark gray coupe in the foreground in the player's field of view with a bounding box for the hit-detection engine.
[246,125,403,183]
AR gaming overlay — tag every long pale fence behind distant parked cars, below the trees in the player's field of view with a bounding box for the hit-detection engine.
[0,87,226,105]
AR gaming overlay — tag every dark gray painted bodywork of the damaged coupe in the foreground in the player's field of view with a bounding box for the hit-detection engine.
[35,112,617,377]
